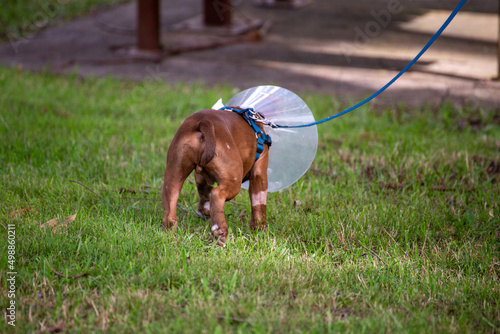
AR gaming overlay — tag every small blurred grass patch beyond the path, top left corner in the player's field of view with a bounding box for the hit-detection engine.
[0,0,129,42]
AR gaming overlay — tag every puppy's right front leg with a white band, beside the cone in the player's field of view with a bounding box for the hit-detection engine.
[248,149,269,230]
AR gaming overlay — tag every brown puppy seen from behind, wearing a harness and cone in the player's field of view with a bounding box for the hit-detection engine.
[162,109,269,243]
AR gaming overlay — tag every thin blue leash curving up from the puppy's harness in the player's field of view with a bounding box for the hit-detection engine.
[272,0,467,128]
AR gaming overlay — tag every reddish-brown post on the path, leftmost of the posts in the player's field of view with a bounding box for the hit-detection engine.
[137,0,160,52]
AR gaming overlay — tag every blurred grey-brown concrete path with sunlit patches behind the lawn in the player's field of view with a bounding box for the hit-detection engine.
[0,0,500,110]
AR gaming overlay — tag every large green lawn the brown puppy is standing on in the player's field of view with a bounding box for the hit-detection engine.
[0,68,500,333]
